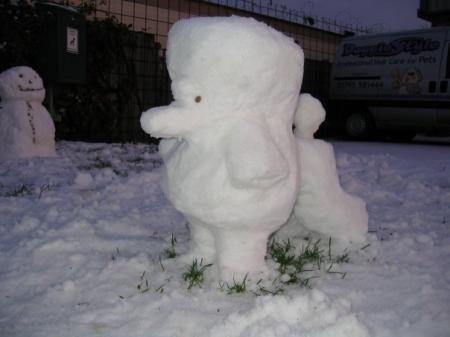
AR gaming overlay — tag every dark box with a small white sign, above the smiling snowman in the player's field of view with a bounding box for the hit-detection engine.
[36,3,86,83]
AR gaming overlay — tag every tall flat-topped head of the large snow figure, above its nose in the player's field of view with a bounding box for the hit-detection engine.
[167,16,304,119]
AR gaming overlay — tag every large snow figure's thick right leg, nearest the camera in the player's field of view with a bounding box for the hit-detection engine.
[216,229,270,282]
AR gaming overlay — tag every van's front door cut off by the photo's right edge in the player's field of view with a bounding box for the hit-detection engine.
[436,38,450,130]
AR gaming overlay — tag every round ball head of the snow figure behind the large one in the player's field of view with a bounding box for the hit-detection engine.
[294,94,326,139]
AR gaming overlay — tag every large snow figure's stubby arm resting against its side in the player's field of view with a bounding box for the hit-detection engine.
[225,124,289,188]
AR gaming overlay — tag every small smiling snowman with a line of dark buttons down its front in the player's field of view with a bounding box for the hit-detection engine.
[0,66,56,160]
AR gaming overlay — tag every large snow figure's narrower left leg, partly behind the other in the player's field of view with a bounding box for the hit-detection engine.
[185,219,216,263]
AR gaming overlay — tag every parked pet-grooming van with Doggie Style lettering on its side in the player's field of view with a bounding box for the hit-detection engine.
[330,27,450,139]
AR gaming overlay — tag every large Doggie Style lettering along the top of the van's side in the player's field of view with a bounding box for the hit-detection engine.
[341,37,441,57]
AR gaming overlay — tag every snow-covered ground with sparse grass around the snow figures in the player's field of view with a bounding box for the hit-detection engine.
[0,142,450,337]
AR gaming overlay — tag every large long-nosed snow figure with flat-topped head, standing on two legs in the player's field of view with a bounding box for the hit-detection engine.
[141,17,303,278]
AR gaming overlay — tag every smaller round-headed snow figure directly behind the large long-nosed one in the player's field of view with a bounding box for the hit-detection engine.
[294,94,368,242]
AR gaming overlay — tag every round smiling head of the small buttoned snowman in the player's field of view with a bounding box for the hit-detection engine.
[0,66,45,102]
